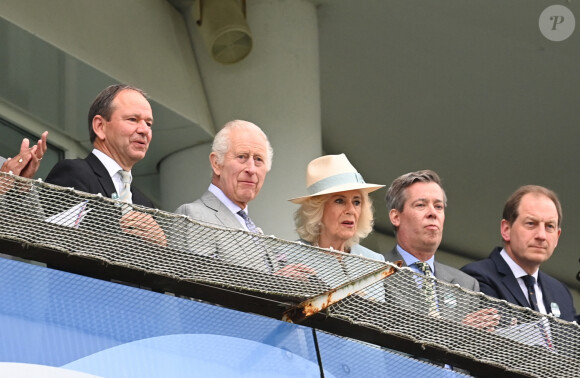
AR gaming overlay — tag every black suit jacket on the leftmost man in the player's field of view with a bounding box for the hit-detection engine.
[45,153,155,207]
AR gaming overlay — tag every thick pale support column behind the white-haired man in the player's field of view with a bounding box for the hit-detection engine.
[161,0,322,240]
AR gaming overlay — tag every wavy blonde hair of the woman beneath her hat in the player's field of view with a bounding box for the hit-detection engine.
[294,190,374,248]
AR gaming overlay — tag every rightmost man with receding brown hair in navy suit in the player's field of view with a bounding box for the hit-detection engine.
[461,185,576,321]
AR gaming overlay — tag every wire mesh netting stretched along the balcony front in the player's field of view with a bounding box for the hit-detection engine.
[0,174,580,377]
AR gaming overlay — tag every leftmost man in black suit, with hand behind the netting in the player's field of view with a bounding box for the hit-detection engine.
[45,84,166,245]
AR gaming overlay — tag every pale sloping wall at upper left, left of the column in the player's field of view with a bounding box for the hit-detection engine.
[0,0,214,133]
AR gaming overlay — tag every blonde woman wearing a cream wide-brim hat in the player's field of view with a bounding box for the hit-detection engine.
[289,154,385,261]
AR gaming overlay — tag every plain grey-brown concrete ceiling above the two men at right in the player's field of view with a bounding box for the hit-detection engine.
[318,0,580,289]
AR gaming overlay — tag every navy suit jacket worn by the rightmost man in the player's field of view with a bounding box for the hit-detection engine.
[461,247,576,321]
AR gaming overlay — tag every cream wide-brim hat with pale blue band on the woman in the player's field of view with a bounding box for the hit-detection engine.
[288,154,384,203]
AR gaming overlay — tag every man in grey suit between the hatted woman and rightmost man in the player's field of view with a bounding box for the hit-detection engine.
[385,170,499,328]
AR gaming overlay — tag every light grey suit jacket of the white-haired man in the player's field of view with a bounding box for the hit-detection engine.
[174,191,275,273]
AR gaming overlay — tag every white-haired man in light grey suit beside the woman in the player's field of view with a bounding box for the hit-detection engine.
[176,120,274,272]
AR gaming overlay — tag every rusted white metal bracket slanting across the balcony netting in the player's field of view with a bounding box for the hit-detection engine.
[282,260,403,323]
